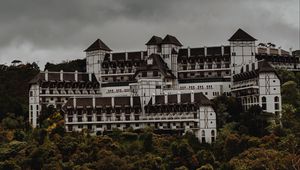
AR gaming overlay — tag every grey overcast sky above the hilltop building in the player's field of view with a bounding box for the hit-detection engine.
[0,0,300,67]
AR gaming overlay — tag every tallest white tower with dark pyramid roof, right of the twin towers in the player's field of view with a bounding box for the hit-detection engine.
[228,29,256,75]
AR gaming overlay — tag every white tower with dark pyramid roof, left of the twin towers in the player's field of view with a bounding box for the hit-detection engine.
[84,39,112,83]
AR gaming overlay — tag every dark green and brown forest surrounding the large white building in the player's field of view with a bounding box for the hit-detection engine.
[0,60,300,170]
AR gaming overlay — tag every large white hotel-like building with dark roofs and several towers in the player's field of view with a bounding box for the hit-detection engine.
[29,29,300,142]
